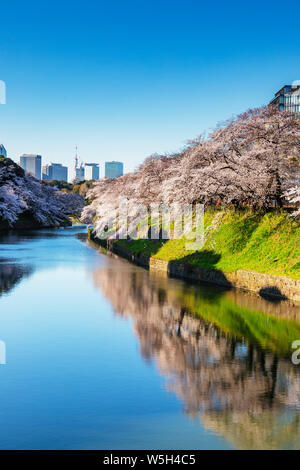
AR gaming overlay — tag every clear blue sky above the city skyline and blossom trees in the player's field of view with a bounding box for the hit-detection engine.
[0,0,300,177]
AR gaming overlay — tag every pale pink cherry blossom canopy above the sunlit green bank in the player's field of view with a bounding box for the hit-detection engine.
[83,106,300,239]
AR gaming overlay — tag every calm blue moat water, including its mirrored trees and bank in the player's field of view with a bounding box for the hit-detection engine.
[0,226,300,449]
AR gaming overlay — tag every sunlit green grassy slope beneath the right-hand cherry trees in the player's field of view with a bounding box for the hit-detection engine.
[115,209,300,279]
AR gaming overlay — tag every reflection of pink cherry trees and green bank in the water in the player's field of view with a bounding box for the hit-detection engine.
[93,260,300,449]
